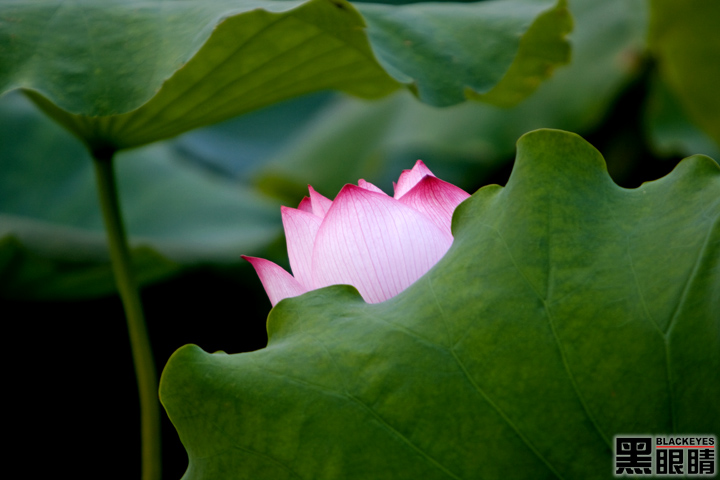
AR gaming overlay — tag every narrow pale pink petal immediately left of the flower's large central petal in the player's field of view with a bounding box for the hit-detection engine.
[280,207,322,290]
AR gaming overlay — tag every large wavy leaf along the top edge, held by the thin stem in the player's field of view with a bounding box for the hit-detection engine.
[0,0,569,149]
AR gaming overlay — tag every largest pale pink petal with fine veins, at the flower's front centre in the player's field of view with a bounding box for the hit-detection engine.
[312,185,452,303]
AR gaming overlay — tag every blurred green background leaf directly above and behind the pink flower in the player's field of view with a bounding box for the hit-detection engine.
[255,0,648,199]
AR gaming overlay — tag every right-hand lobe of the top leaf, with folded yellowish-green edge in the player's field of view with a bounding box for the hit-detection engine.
[357,0,572,106]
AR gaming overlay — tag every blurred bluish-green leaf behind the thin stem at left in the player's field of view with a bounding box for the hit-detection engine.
[0,94,282,298]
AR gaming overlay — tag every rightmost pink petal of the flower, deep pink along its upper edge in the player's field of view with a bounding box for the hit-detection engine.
[398,176,470,234]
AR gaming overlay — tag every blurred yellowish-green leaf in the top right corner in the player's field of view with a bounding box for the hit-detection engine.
[650,0,720,148]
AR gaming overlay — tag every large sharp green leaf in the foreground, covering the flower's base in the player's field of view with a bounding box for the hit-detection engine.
[160,130,720,480]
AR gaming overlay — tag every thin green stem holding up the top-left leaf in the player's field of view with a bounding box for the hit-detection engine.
[93,150,161,480]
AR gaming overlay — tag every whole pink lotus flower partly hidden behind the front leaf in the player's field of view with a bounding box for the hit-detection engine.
[243,160,470,306]
